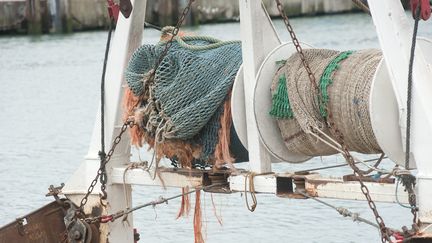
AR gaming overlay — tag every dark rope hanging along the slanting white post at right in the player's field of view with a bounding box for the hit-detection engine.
[405,4,421,169]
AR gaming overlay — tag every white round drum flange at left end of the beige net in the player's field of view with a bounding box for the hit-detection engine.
[253,42,311,163]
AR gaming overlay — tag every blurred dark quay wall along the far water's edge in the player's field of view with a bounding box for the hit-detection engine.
[0,0,398,35]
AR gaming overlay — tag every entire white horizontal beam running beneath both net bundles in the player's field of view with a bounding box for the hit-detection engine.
[108,167,408,204]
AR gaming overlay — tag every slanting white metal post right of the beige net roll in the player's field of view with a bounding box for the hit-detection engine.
[369,0,432,223]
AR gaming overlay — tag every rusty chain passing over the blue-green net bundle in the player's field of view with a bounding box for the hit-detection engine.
[77,0,195,218]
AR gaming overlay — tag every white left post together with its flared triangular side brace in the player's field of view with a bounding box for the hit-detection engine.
[63,0,147,243]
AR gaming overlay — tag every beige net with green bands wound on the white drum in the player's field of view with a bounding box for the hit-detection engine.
[270,49,382,156]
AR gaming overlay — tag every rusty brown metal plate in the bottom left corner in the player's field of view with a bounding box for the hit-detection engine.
[0,201,67,243]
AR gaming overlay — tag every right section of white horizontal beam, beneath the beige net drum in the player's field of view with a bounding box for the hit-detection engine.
[229,173,408,204]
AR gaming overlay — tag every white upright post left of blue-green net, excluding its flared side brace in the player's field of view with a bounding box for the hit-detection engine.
[105,0,147,242]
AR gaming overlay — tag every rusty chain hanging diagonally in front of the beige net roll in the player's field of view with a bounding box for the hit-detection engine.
[275,0,391,243]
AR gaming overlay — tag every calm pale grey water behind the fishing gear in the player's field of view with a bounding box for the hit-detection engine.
[0,14,432,243]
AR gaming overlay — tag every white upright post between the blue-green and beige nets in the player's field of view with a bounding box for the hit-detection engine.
[239,0,280,173]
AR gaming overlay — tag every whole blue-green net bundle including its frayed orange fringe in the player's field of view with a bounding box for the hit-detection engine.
[125,32,242,167]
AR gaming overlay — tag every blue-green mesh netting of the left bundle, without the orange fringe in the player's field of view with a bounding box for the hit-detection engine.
[125,36,242,159]
